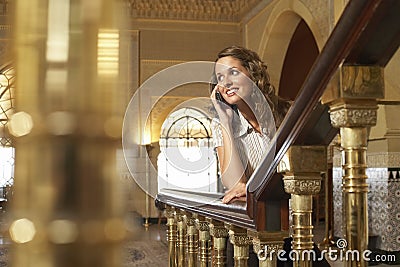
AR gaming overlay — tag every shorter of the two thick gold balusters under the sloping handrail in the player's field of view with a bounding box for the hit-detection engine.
[278,146,327,267]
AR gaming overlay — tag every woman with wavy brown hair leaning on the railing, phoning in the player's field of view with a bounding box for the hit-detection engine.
[211,46,290,203]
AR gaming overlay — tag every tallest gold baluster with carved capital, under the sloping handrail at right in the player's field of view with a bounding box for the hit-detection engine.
[322,65,384,266]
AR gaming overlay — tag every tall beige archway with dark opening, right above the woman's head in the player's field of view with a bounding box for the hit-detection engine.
[258,0,327,99]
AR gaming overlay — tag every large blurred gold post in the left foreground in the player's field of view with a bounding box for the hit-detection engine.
[9,0,128,267]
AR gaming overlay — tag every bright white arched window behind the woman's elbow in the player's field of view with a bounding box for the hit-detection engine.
[157,108,221,192]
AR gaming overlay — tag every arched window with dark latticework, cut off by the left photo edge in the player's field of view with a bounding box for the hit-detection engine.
[0,65,15,203]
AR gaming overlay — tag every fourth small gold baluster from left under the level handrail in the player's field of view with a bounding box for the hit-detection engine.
[196,215,211,267]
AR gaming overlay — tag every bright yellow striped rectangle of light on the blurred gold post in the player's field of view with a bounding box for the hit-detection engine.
[97,29,119,76]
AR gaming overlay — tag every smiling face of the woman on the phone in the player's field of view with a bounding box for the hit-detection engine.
[215,56,253,105]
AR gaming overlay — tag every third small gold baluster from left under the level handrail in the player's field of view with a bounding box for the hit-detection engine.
[184,212,199,267]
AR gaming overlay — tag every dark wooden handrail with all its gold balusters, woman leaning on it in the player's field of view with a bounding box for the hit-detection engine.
[156,0,400,266]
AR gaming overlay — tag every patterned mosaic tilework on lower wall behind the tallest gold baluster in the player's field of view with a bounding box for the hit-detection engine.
[333,167,400,251]
